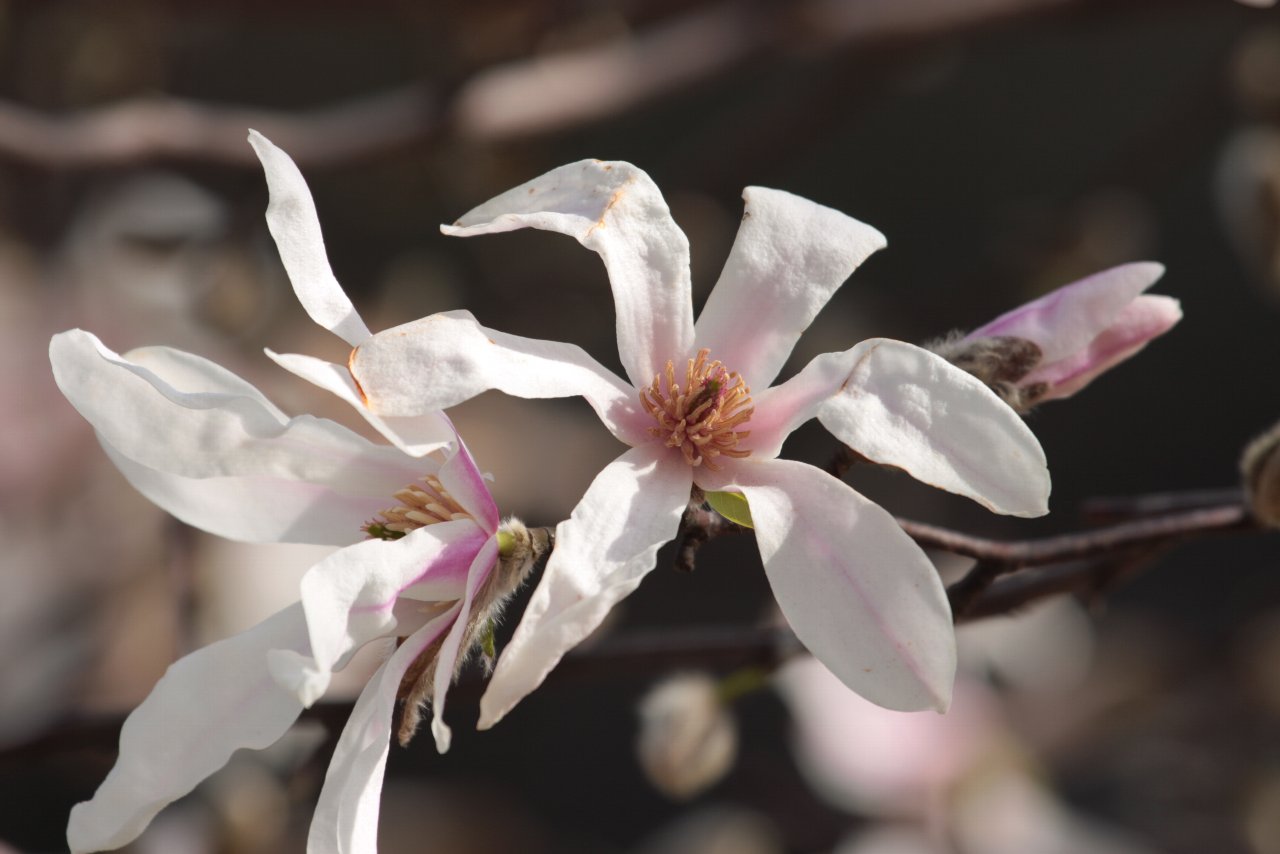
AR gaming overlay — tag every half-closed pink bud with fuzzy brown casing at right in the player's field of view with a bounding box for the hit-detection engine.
[933,262,1183,411]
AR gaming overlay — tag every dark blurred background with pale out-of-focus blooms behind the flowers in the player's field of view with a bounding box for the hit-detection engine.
[0,0,1280,854]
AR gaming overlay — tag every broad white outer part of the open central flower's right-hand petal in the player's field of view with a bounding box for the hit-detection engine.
[818,338,1050,516]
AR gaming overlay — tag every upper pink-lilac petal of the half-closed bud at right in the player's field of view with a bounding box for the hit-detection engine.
[965,261,1165,365]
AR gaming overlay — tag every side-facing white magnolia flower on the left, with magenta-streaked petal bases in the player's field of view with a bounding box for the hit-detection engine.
[50,138,540,854]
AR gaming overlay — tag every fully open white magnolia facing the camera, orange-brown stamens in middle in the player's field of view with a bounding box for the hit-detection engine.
[285,161,1050,727]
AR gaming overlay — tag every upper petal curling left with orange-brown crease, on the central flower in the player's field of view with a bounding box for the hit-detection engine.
[440,160,694,387]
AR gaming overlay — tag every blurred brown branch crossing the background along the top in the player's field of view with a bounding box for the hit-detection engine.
[0,0,1208,169]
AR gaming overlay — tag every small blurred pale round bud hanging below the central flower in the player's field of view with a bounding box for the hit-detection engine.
[636,673,737,800]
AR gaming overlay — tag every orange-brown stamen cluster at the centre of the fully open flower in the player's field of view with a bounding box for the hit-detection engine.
[640,348,755,471]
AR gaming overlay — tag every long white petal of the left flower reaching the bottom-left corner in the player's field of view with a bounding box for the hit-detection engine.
[67,604,308,854]
